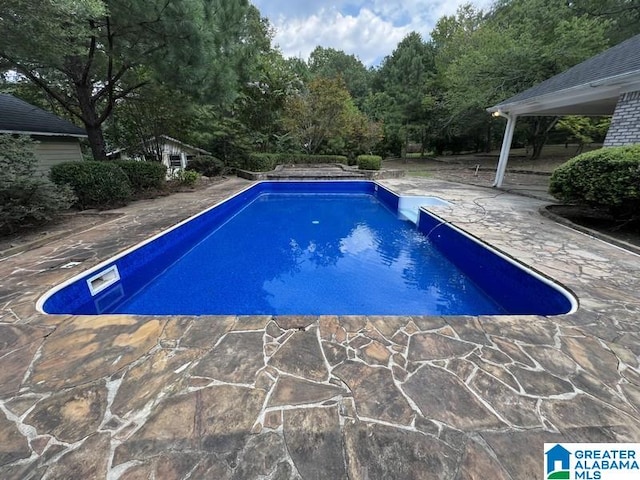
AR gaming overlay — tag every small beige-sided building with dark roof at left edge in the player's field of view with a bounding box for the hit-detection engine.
[0,93,87,175]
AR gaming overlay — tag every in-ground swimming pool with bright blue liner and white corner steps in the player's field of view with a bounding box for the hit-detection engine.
[38,181,575,315]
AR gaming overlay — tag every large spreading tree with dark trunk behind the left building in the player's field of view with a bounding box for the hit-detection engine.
[0,0,251,159]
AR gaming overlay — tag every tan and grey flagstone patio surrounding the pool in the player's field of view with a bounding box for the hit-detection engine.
[0,178,640,480]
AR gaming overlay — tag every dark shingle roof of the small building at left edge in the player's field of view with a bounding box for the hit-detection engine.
[0,93,87,137]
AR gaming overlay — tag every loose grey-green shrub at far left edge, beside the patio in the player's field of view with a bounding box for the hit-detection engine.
[0,135,75,233]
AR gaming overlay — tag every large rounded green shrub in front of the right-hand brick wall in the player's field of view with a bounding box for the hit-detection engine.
[549,144,640,215]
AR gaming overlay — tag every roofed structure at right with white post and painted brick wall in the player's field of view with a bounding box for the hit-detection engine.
[487,35,640,187]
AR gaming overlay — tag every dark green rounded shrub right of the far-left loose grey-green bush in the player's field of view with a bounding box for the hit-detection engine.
[50,161,133,209]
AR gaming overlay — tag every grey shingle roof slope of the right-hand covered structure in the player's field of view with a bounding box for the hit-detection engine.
[496,35,640,107]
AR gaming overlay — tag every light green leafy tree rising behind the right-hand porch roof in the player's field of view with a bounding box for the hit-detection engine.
[443,0,608,158]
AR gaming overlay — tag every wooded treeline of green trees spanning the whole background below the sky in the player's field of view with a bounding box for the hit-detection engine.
[0,0,640,165]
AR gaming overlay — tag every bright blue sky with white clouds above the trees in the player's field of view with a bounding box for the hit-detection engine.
[252,0,492,66]
